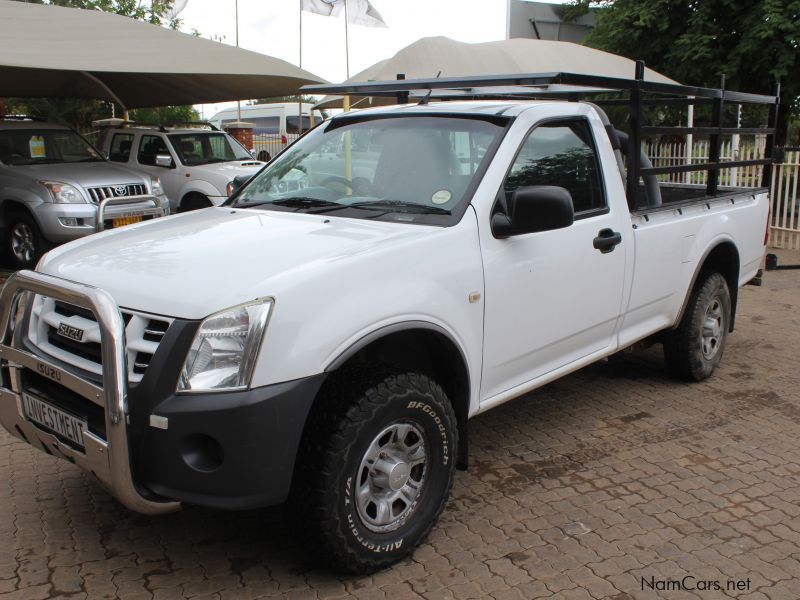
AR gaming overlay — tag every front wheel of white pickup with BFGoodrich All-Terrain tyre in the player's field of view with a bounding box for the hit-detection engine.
[294,373,458,573]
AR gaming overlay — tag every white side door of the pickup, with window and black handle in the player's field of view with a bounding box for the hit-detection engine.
[481,117,630,401]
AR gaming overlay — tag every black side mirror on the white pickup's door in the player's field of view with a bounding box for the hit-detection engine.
[491,185,575,239]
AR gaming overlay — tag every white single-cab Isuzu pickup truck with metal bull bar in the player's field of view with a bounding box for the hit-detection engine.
[0,72,769,572]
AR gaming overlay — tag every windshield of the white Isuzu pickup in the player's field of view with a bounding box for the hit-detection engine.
[233,116,504,224]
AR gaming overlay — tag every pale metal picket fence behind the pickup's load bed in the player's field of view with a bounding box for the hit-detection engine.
[642,136,800,250]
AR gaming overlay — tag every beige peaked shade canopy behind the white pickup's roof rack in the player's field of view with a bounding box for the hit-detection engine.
[317,37,676,108]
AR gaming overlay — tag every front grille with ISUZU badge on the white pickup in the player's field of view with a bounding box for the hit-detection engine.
[28,296,172,384]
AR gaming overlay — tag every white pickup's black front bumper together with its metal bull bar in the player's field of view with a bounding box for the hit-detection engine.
[0,271,325,514]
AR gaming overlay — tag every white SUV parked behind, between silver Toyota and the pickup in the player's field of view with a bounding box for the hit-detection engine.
[97,119,264,212]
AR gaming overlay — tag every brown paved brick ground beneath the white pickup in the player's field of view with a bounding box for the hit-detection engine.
[0,253,800,600]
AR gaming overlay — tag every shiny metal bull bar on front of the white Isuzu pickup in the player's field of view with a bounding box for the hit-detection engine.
[0,271,180,515]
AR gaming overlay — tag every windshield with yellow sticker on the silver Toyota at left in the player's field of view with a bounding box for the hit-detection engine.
[0,129,104,166]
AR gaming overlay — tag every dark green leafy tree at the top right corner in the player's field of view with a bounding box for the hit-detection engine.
[564,0,800,144]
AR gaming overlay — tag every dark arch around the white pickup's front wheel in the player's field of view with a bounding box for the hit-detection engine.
[318,321,471,469]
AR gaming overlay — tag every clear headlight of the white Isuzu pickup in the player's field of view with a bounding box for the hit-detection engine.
[177,298,273,392]
